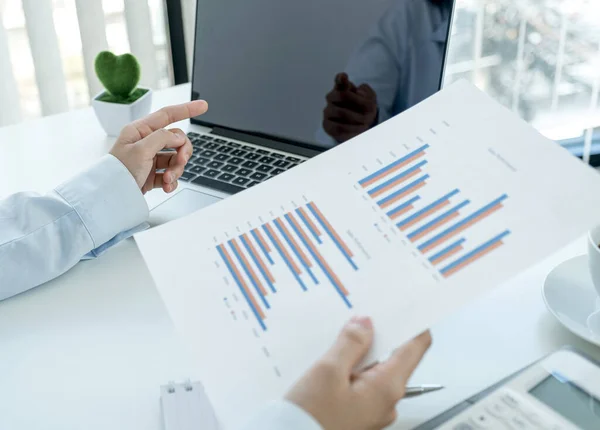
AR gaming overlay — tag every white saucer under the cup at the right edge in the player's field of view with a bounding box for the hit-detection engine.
[542,255,600,346]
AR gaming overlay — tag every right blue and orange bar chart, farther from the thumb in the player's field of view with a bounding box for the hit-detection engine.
[358,144,510,278]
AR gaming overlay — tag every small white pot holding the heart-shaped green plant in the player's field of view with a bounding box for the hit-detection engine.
[92,89,152,137]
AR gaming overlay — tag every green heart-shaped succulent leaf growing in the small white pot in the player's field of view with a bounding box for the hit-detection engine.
[95,51,142,99]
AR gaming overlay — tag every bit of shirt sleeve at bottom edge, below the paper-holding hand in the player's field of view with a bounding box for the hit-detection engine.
[240,400,323,430]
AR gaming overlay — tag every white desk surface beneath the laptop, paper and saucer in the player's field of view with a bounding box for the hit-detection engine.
[0,86,600,430]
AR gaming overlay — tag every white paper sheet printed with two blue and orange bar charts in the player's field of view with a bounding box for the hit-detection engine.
[136,82,600,429]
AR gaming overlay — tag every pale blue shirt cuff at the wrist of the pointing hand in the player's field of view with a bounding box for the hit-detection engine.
[55,155,149,248]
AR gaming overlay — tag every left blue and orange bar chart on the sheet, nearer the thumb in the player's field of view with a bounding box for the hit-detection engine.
[216,202,359,331]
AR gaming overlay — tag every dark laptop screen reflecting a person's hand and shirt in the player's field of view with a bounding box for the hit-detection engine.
[192,0,453,148]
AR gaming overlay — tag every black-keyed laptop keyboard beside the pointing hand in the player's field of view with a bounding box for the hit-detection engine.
[180,133,306,194]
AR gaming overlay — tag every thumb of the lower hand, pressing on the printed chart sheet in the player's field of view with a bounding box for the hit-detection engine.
[326,317,373,374]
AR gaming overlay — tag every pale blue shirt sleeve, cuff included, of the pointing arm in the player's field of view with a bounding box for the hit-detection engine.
[0,155,148,300]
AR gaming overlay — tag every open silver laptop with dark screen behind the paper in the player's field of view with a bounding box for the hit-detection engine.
[150,0,454,224]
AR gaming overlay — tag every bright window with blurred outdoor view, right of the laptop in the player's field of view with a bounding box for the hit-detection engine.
[445,0,600,162]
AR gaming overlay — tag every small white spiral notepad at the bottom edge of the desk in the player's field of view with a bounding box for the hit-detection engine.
[160,381,219,430]
